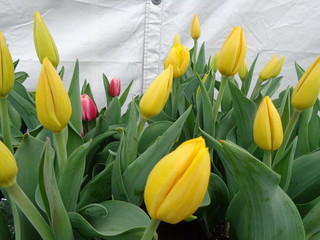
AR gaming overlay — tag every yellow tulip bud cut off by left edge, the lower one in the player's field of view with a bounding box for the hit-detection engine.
[0,141,18,187]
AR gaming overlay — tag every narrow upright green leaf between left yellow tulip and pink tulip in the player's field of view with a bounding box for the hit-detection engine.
[68,60,82,134]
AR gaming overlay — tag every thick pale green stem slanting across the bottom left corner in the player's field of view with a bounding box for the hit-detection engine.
[6,182,54,240]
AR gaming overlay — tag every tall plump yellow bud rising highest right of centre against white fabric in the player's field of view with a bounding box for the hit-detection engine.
[218,27,247,77]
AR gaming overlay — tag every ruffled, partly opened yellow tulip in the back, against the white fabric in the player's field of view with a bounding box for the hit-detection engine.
[163,43,190,78]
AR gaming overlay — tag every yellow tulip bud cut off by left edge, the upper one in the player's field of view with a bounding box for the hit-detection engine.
[0,32,14,97]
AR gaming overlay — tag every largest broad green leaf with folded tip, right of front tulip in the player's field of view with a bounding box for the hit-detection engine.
[222,141,304,240]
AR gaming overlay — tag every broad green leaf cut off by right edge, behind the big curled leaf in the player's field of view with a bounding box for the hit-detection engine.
[287,150,320,203]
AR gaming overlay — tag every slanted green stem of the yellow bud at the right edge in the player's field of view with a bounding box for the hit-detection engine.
[272,111,300,167]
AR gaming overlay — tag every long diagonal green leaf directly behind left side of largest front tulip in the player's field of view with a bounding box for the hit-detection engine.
[123,107,191,205]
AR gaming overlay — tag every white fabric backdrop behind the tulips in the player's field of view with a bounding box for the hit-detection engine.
[0,0,320,107]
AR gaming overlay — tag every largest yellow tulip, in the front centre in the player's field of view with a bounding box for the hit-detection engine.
[144,137,210,224]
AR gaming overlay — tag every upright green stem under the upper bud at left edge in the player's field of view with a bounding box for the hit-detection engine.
[0,97,13,153]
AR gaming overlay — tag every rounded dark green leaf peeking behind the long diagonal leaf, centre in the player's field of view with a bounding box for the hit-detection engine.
[138,121,172,154]
